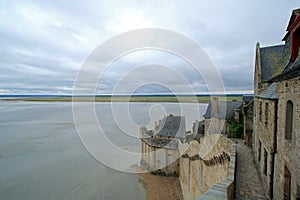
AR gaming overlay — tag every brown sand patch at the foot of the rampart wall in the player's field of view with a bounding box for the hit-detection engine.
[134,166,183,200]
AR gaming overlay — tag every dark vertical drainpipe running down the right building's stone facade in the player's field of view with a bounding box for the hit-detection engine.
[270,99,278,199]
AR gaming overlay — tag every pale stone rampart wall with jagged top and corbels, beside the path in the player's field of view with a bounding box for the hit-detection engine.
[179,134,233,199]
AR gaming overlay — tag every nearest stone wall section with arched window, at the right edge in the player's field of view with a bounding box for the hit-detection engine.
[274,77,300,199]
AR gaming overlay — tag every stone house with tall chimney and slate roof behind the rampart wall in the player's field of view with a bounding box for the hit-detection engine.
[203,97,242,135]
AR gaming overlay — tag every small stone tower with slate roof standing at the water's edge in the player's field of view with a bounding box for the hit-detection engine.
[140,115,187,176]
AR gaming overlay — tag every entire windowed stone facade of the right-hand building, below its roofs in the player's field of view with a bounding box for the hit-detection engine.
[253,77,300,199]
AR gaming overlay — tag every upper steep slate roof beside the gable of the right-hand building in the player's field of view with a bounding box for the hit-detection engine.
[260,45,286,81]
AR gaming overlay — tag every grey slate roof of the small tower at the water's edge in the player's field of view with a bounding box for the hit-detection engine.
[156,115,185,138]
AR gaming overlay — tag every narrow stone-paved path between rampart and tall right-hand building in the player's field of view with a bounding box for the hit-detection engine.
[235,140,268,200]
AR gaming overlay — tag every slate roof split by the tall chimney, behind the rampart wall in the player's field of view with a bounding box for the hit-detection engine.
[203,101,242,119]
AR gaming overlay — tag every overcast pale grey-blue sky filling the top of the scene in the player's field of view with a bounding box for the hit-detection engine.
[0,0,299,94]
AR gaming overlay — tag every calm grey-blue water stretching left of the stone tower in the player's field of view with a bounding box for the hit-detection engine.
[0,100,207,200]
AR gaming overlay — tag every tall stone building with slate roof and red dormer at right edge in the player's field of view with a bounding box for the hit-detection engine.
[253,9,300,199]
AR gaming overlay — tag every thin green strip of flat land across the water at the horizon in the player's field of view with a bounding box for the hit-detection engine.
[0,95,242,103]
